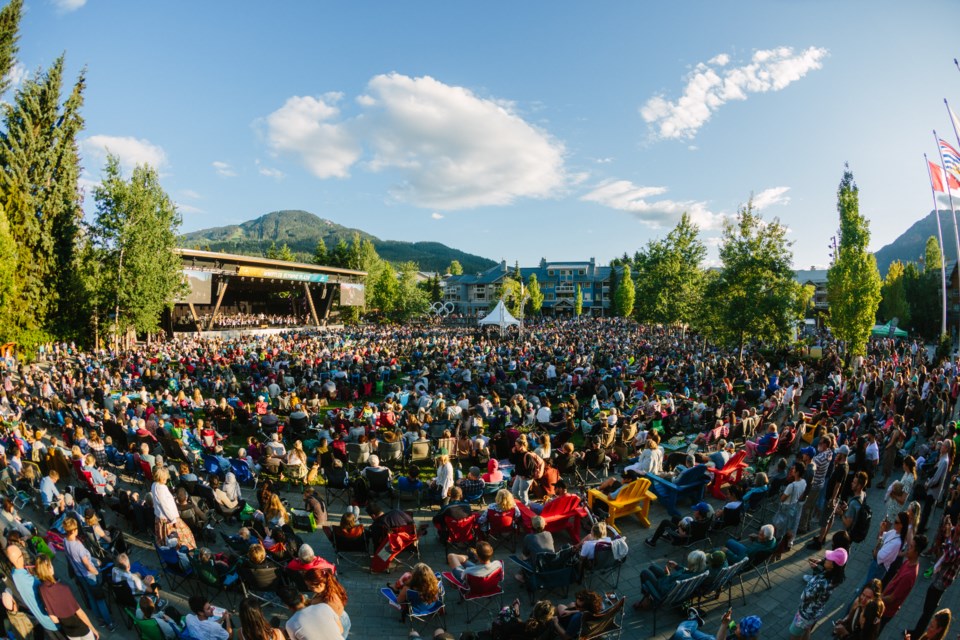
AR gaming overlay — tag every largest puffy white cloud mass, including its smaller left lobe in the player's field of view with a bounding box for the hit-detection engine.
[265,73,569,210]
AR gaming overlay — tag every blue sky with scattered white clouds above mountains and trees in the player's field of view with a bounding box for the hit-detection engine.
[20,0,960,268]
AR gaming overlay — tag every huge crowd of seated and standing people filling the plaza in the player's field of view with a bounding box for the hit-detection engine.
[0,319,960,640]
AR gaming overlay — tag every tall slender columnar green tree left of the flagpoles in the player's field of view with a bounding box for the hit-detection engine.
[827,166,881,356]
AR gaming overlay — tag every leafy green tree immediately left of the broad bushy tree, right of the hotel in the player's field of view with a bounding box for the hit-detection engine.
[635,213,707,325]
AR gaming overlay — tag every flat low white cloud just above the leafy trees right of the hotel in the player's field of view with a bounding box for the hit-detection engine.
[580,180,724,230]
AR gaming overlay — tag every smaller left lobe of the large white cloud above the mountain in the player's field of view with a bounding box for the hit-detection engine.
[266,94,360,178]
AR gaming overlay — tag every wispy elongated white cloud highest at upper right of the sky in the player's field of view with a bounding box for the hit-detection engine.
[640,47,827,138]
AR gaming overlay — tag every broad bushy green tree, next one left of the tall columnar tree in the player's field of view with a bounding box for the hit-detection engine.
[701,198,803,357]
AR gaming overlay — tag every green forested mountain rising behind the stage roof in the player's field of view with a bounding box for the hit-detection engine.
[179,211,496,273]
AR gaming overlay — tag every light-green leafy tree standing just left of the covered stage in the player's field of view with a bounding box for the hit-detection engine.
[91,155,185,338]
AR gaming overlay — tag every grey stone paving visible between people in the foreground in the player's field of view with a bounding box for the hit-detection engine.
[50,460,944,640]
